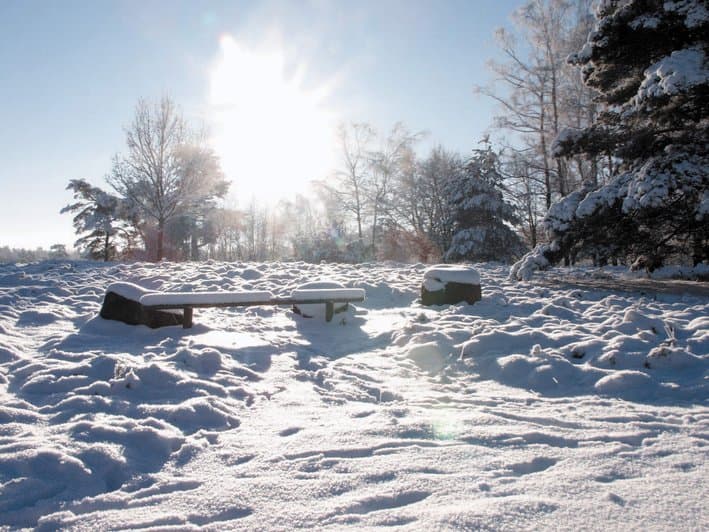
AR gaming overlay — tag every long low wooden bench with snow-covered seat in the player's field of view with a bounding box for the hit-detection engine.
[139,288,365,329]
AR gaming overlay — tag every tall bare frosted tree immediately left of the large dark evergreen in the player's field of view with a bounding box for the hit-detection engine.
[478,0,600,249]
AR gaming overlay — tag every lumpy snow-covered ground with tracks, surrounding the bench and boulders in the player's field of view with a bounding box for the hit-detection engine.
[0,262,709,530]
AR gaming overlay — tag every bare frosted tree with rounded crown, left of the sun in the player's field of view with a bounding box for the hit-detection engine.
[108,97,229,260]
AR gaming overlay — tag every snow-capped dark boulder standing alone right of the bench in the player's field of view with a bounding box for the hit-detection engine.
[421,264,482,306]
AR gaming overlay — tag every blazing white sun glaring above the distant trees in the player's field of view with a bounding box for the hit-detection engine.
[209,36,336,204]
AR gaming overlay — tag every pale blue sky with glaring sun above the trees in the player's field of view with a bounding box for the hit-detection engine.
[0,0,521,248]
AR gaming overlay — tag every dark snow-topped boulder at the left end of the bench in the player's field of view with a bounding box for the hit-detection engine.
[99,283,182,329]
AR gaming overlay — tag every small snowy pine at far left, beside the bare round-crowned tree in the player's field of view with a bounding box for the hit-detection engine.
[61,179,134,261]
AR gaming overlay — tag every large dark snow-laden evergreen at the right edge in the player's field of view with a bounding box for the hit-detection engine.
[546,0,709,269]
